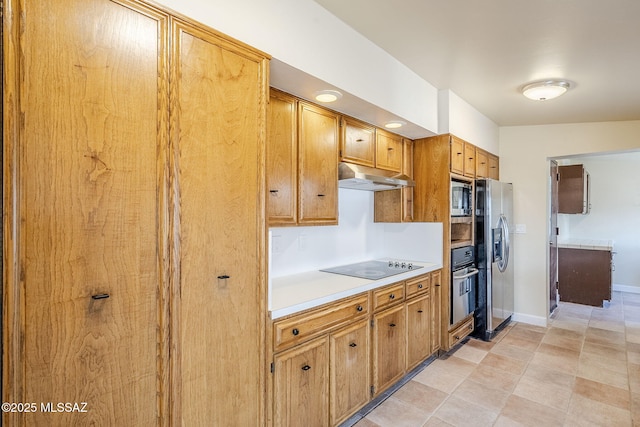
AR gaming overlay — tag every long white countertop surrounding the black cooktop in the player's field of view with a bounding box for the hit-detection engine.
[270,262,442,319]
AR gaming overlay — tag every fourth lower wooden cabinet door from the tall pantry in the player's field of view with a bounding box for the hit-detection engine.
[407,294,431,369]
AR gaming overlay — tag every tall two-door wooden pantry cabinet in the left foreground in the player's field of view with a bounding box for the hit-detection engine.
[2,0,268,426]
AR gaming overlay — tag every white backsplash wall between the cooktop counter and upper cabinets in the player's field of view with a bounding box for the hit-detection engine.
[269,188,442,278]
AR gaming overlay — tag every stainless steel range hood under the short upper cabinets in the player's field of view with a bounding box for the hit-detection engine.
[338,162,415,191]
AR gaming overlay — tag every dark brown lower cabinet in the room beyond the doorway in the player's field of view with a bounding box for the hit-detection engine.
[558,247,613,307]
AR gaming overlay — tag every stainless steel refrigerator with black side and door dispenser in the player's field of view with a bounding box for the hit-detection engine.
[473,179,515,341]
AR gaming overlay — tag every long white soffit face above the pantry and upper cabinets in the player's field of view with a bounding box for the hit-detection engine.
[158,0,438,133]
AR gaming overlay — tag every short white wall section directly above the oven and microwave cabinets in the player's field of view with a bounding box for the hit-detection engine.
[438,89,499,154]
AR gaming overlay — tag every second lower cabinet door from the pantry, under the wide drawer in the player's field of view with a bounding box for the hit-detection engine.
[330,320,370,425]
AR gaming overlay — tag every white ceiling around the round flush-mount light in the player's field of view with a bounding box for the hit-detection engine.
[315,0,640,126]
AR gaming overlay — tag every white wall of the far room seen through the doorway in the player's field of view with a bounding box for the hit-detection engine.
[558,152,640,292]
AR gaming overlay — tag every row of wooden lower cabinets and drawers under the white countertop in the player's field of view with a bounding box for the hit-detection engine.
[271,270,441,427]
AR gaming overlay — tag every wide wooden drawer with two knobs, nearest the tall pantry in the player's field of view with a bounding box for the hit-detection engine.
[273,294,369,352]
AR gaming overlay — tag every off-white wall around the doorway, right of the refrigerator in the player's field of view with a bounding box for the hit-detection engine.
[499,121,640,319]
